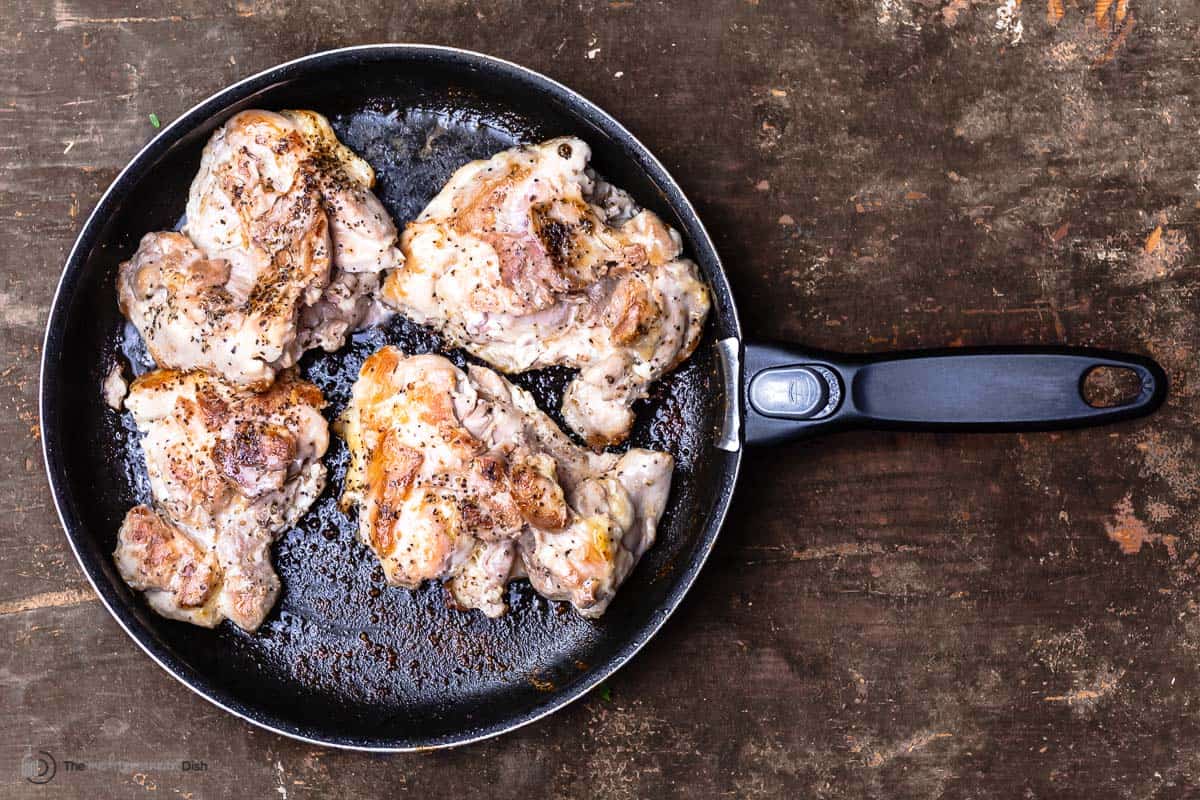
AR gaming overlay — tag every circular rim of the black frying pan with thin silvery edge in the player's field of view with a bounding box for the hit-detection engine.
[38,43,743,753]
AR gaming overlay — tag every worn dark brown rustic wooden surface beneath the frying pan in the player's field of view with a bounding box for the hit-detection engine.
[0,0,1200,799]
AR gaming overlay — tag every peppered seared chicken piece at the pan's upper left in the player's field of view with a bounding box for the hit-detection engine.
[118,110,403,389]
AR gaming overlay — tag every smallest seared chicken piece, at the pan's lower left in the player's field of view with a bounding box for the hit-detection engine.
[114,369,329,631]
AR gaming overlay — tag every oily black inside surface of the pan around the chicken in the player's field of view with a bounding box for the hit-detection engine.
[43,51,737,747]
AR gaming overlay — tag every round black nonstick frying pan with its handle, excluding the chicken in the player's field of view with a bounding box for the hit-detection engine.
[41,44,1166,751]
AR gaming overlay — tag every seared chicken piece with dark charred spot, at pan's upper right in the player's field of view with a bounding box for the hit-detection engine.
[384,138,709,446]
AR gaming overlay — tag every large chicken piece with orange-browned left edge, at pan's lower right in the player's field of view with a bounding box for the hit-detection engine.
[336,347,673,616]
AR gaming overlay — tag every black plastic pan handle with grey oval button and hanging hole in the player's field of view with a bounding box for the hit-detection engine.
[743,344,1166,444]
